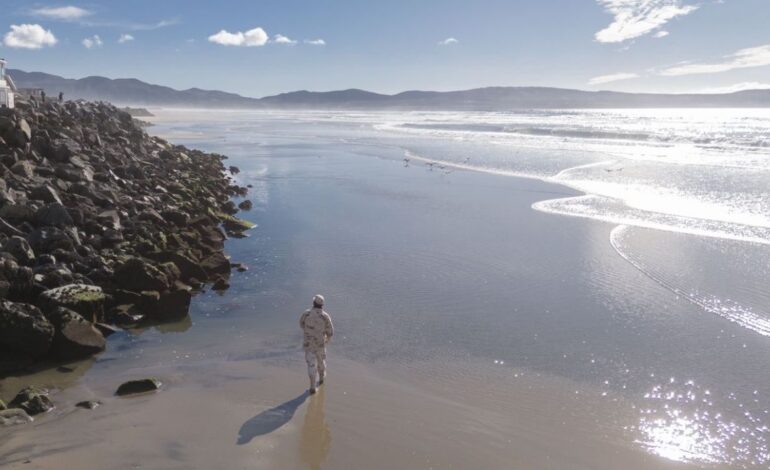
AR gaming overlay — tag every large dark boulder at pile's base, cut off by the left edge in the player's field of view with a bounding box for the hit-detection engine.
[0,300,54,358]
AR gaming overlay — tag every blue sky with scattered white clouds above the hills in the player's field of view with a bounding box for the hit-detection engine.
[0,0,770,97]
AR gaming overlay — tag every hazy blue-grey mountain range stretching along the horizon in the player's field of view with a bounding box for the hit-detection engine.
[9,70,770,111]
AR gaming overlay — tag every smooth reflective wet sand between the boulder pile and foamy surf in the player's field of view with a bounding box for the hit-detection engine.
[0,110,770,469]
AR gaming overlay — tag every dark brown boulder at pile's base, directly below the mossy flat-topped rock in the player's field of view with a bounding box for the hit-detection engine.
[49,307,106,359]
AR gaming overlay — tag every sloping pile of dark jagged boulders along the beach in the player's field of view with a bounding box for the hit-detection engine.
[0,98,251,386]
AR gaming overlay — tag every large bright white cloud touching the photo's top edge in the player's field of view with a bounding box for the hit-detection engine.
[594,0,698,43]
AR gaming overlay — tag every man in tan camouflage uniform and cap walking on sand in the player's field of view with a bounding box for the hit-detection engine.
[299,295,334,394]
